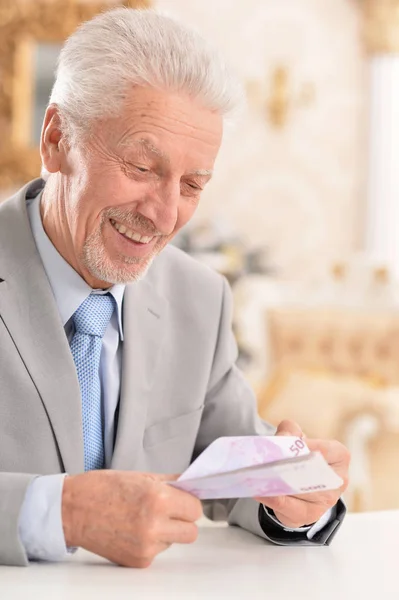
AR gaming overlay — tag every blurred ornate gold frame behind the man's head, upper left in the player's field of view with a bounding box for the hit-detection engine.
[0,0,151,189]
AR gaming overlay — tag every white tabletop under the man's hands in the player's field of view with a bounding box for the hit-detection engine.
[0,511,399,600]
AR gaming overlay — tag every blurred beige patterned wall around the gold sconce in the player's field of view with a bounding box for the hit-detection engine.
[156,0,367,276]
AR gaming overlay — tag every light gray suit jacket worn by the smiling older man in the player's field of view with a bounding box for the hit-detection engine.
[0,184,344,565]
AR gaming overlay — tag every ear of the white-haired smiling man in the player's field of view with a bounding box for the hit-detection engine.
[40,104,62,173]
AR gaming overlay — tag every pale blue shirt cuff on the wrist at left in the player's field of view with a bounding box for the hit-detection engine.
[18,474,75,561]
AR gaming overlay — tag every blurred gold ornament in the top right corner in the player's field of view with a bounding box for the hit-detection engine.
[363,0,399,54]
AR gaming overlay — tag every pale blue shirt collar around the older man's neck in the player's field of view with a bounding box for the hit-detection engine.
[27,193,126,341]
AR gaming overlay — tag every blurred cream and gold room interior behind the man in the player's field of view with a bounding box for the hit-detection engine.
[0,0,399,511]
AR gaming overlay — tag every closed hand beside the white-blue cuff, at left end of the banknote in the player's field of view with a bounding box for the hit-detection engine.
[62,471,202,567]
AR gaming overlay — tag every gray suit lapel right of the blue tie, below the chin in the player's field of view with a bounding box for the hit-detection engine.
[111,276,167,470]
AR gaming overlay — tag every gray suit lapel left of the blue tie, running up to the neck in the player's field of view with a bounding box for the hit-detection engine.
[0,187,84,474]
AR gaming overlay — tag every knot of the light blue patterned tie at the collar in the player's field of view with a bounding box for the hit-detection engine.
[73,294,115,338]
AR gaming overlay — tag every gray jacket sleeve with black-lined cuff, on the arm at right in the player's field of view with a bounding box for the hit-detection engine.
[193,279,345,545]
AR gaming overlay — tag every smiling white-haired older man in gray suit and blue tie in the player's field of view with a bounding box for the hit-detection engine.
[0,9,349,567]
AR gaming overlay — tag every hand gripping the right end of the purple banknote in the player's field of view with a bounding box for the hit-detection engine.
[256,421,350,529]
